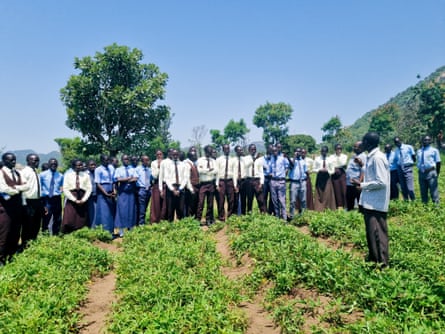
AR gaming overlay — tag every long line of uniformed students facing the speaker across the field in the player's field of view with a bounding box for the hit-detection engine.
[0,136,442,264]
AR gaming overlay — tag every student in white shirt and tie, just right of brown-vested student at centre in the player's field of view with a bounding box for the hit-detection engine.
[196,145,216,226]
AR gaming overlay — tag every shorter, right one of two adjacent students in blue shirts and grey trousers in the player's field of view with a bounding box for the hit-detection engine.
[288,147,307,220]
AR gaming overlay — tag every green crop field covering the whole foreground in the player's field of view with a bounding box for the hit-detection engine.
[0,179,445,333]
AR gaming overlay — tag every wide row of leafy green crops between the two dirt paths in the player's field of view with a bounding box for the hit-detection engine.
[109,219,247,333]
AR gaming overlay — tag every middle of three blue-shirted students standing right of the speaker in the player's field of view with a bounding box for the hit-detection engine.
[394,137,416,201]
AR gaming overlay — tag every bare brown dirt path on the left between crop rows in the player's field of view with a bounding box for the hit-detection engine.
[79,239,121,334]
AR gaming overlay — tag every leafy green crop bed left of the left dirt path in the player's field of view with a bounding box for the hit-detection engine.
[0,235,112,334]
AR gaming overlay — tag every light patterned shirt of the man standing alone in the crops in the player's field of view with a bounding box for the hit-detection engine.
[359,147,390,212]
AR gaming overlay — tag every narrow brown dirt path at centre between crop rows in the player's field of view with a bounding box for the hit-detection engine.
[215,227,280,334]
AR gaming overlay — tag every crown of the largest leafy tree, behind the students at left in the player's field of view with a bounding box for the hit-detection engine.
[61,44,170,155]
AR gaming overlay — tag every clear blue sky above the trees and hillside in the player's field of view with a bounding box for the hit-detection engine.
[0,0,445,153]
